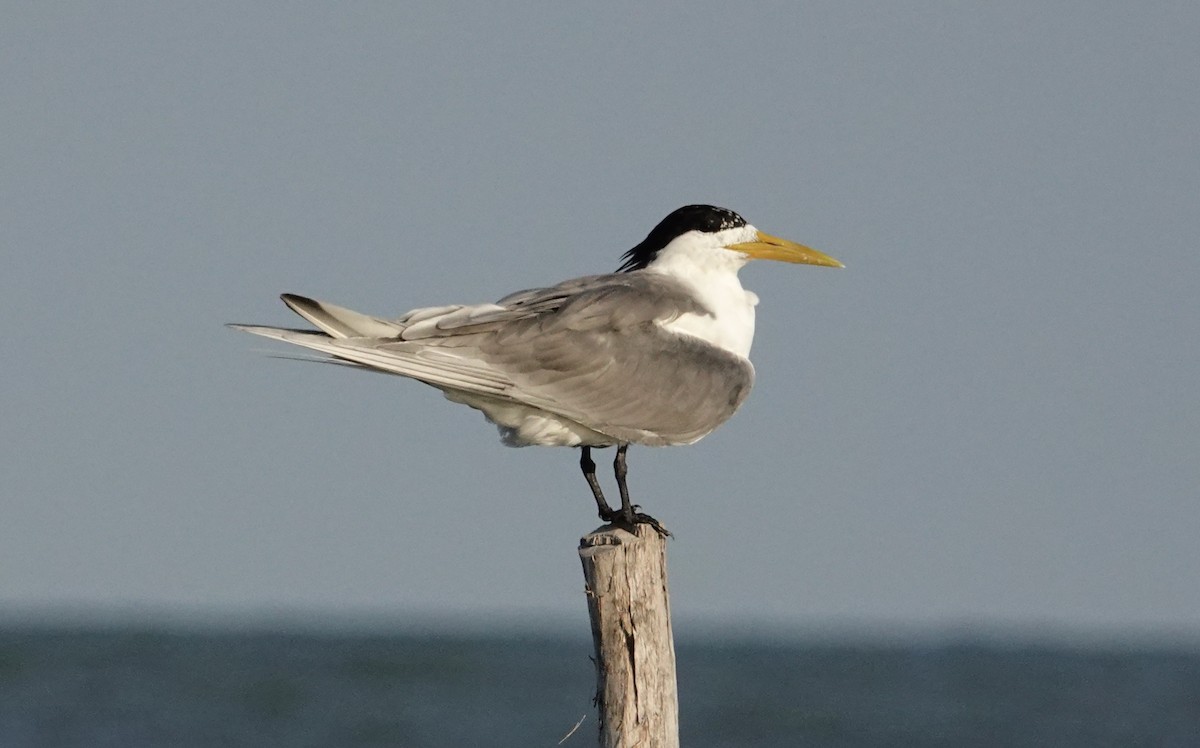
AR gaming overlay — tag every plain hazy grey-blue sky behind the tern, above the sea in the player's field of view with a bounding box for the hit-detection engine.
[0,2,1200,636]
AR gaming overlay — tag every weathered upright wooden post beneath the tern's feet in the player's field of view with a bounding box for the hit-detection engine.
[580,525,679,748]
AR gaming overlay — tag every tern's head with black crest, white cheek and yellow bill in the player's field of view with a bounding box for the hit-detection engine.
[617,205,845,273]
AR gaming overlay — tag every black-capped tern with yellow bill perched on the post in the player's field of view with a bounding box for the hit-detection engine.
[229,205,845,534]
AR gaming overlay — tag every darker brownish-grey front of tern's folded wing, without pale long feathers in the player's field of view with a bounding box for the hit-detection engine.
[480,274,754,444]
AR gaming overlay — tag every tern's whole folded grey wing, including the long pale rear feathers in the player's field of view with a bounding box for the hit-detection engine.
[230,271,754,444]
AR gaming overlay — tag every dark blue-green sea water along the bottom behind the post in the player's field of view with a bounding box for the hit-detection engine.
[0,627,1200,748]
